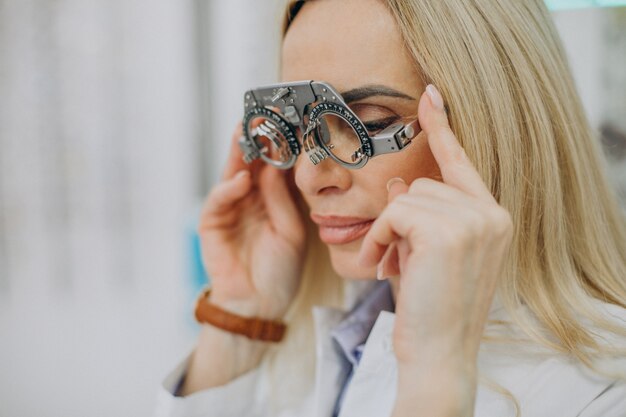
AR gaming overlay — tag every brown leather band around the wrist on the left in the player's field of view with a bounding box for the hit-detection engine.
[195,288,287,342]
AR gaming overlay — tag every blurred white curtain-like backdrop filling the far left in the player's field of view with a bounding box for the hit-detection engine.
[0,0,200,417]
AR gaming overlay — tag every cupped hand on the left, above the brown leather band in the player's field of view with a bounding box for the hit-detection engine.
[199,124,305,319]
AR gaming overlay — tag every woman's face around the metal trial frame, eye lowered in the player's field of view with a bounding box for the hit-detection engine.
[281,0,440,279]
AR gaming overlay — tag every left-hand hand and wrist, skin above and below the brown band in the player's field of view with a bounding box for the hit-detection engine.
[179,122,305,396]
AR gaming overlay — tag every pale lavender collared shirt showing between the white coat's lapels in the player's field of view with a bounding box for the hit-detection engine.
[331,280,395,417]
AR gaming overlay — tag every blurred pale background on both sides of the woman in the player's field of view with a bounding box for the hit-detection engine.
[0,0,626,417]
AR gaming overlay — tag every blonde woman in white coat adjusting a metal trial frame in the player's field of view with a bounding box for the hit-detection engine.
[158,0,626,417]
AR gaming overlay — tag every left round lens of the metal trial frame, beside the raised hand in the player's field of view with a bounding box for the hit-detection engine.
[248,116,291,166]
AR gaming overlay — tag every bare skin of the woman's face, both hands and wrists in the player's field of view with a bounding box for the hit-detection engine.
[182,0,512,417]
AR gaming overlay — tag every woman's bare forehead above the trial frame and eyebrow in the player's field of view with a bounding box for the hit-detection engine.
[281,0,417,91]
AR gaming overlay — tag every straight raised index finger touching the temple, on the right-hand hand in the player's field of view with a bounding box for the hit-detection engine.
[417,84,493,199]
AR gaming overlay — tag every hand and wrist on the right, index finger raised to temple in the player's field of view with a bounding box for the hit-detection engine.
[359,86,513,416]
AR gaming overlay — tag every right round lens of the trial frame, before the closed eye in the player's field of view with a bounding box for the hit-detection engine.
[317,113,363,164]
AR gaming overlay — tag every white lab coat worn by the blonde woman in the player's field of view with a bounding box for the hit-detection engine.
[154,290,626,417]
